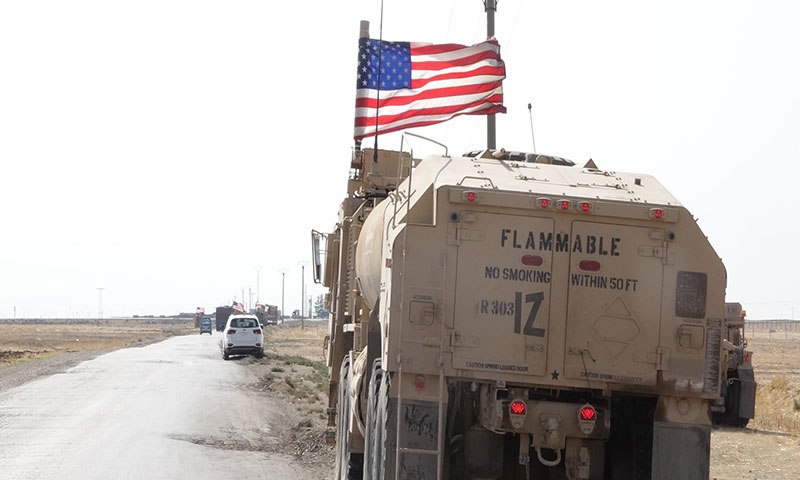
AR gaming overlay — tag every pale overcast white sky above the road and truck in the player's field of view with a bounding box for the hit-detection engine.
[0,0,800,319]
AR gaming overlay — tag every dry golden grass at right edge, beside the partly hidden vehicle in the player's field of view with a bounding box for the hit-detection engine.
[748,331,800,435]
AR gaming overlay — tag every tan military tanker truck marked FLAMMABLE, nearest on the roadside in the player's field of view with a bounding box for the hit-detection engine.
[312,148,726,480]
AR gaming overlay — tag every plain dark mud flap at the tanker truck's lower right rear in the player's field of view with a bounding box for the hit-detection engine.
[652,422,711,480]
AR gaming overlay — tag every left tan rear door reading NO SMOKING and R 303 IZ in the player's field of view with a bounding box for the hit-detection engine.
[452,212,554,375]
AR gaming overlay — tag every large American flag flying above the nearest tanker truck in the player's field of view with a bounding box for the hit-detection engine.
[355,38,506,140]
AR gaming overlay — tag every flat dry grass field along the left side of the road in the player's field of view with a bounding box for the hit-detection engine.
[0,320,196,369]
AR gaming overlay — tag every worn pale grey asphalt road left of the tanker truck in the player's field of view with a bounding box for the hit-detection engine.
[0,334,318,480]
